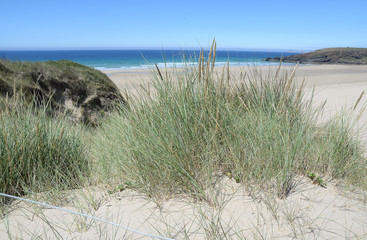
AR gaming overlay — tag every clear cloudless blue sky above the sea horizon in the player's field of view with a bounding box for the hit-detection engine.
[0,0,367,50]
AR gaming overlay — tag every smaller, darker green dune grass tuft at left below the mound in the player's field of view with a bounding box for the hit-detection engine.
[0,94,90,201]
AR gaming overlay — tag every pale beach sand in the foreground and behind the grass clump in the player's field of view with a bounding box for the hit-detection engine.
[0,65,367,239]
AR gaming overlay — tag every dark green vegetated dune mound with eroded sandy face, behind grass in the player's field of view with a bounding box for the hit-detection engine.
[0,60,125,125]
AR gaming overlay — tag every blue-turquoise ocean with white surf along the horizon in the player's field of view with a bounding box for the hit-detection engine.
[0,50,296,70]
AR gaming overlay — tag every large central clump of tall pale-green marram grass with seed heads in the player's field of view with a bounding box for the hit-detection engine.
[92,42,367,199]
